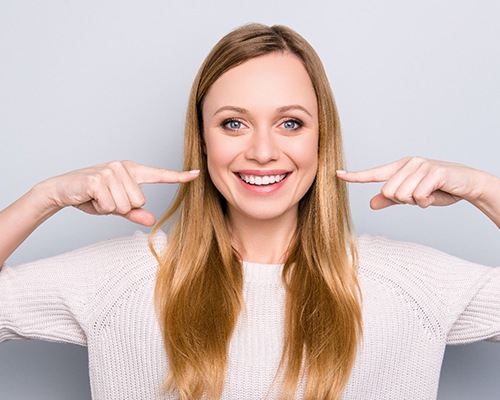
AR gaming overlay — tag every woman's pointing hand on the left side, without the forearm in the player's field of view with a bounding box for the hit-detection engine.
[37,161,199,226]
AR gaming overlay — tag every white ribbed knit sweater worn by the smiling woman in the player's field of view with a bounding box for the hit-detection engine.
[0,233,500,400]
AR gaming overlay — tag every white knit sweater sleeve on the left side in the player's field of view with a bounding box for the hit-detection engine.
[0,233,161,345]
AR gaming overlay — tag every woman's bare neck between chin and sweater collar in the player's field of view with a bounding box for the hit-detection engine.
[227,208,297,264]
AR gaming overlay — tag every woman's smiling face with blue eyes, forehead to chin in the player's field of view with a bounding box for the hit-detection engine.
[202,53,318,220]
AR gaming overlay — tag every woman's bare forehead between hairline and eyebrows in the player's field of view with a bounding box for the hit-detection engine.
[203,53,317,116]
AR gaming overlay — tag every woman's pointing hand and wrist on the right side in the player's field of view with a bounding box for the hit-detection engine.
[337,157,500,227]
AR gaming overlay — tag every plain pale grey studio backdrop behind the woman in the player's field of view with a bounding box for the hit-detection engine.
[0,0,500,400]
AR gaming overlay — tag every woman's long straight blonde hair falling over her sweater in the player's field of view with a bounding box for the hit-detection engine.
[153,24,362,399]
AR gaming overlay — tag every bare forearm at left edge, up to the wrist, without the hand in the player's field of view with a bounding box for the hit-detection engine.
[0,184,59,265]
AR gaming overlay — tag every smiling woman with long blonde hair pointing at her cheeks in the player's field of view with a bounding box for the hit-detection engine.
[0,25,500,399]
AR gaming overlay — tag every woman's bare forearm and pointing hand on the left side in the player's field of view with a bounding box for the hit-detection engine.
[0,161,199,265]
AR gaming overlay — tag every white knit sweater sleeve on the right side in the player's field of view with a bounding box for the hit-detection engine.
[360,237,500,344]
